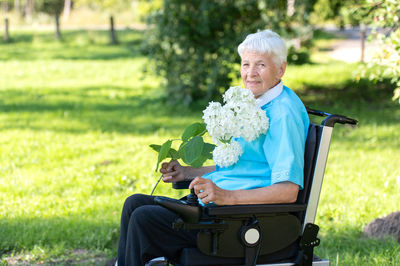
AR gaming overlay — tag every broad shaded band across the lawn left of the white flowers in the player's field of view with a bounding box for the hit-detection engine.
[0,86,201,135]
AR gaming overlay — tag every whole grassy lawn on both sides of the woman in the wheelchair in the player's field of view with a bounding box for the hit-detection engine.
[0,31,400,265]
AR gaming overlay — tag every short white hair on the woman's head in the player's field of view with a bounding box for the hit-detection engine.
[238,30,287,67]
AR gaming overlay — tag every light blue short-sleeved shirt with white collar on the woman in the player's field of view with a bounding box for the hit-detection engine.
[204,82,310,194]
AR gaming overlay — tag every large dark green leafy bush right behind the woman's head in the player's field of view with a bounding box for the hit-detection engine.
[146,0,315,104]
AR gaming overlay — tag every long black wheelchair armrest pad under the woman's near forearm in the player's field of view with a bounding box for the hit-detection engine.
[204,203,307,216]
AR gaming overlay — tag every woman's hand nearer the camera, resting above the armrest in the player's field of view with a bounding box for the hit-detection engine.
[189,177,230,205]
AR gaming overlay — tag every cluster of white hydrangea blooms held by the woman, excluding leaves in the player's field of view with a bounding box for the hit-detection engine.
[203,87,269,167]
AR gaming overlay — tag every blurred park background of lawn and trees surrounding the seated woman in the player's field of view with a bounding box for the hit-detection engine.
[0,0,400,265]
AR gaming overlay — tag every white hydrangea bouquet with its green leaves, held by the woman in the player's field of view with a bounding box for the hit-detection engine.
[150,87,269,171]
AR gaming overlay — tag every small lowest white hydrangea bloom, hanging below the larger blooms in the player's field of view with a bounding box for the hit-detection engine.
[213,141,243,167]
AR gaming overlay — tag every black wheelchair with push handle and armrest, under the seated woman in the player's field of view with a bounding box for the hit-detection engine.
[155,108,357,266]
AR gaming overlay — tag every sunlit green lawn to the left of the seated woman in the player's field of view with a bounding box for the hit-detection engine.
[0,28,195,261]
